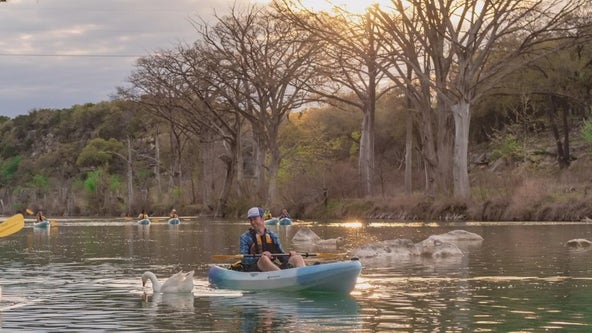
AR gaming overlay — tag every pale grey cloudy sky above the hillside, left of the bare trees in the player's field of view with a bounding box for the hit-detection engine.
[0,0,266,118]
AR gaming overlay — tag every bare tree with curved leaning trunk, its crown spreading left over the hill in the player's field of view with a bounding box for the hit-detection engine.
[125,45,240,216]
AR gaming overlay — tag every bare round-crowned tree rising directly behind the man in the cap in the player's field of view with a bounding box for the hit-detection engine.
[198,2,320,205]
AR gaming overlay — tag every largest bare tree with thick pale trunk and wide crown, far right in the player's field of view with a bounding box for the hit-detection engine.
[375,0,589,199]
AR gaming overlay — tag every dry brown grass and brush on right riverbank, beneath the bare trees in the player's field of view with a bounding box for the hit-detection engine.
[274,130,592,221]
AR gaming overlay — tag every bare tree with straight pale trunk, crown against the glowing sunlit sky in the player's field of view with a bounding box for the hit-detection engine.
[274,0,392,196]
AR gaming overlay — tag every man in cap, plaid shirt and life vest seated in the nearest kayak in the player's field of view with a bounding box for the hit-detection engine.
[240,207,306,272]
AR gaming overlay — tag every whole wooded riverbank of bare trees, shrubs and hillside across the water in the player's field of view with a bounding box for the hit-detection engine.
[0,0,592,220]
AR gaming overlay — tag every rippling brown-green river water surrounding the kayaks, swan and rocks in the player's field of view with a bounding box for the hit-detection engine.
[0,218,592,332]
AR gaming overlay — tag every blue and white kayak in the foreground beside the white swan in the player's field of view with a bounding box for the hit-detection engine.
[208,259,362,294]
